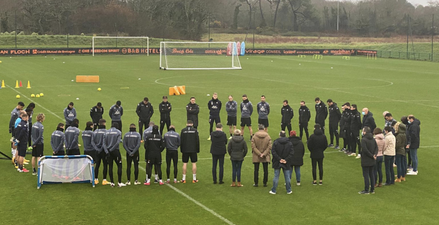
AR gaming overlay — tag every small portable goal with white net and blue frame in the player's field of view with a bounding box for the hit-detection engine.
[37,155,95,189]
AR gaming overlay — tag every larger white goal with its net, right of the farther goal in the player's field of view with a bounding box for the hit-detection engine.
[160,42,242,70]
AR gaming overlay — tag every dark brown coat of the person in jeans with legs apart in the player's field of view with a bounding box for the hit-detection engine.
[271,137,294,170]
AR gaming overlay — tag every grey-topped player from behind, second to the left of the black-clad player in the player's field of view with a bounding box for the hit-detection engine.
[103,123,126,187]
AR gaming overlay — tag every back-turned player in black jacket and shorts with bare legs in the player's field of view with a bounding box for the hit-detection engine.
[180,120,200,184]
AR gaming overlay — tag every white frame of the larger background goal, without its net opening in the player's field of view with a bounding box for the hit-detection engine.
[159,41,242,70]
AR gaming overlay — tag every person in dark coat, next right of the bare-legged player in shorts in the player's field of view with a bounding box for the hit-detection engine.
[210,123,227,184]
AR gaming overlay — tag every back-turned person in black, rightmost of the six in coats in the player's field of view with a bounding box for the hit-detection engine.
[308,124,328,185]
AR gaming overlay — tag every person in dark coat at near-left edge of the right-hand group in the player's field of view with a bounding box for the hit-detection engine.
[358,126,378,194]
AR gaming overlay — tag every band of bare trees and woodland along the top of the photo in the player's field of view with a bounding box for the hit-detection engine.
[0,0,439,40]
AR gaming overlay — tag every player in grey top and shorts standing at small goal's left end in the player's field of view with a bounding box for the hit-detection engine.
[31,113,46,175]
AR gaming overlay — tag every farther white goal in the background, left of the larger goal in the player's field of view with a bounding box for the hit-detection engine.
[91,36,149,56]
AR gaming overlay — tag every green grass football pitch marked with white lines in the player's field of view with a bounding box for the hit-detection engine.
[0,56,439,224]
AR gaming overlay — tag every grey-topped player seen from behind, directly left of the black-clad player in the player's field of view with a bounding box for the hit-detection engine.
[123,123,142,185]
